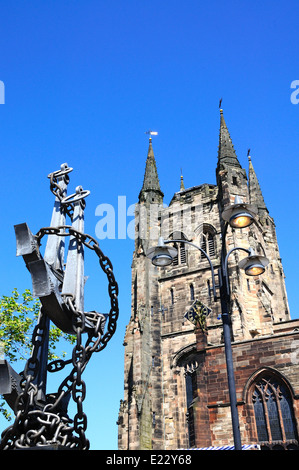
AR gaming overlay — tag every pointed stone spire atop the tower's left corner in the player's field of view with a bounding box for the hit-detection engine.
[139,137,164,202]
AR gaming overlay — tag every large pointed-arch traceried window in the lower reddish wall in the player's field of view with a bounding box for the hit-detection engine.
[251,373,299,449]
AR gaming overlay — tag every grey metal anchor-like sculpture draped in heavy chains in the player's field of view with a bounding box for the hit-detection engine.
[0,163,118,450]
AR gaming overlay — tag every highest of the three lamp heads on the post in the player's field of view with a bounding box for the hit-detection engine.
[222,196,257,228]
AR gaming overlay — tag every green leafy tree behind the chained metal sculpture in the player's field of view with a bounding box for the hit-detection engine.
[0,289,75,420]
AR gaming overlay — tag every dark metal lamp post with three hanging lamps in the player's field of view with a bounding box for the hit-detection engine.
[146,196,269,450]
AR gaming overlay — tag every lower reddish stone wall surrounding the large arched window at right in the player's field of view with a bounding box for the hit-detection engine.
[196,321,299,447]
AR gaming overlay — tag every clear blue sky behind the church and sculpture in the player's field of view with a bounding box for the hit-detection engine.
[0,0,299,449]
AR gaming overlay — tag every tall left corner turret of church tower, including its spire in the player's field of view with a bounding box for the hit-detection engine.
[120,137,164,450]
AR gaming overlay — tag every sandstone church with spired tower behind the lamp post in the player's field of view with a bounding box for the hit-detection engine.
[118,110,299,450]
